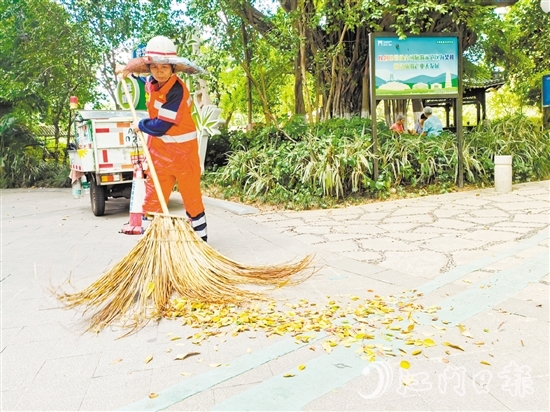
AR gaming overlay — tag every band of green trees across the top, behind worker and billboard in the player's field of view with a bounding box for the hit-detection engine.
[0,0,550,137]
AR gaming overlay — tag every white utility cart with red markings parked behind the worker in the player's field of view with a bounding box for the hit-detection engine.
[68,110,148,216]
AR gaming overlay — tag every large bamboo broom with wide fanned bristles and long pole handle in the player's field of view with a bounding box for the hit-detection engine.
[55,78,313,333]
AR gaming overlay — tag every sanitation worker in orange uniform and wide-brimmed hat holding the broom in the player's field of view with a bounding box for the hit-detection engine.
[122,36,207,241]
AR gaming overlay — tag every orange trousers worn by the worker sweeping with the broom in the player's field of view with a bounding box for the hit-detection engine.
[143,136,204,217]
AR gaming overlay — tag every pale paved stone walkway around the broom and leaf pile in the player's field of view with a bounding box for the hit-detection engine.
[0,181,550,411]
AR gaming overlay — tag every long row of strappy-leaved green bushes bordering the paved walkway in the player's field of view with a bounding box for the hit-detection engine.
[207,112,550,208]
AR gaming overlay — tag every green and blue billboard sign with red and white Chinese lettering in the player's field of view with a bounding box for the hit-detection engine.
[371,34,461,98]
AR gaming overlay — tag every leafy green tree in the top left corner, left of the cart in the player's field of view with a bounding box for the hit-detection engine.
[0,0,99,161]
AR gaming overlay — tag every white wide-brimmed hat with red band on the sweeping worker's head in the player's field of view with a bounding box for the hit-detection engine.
[122,36,206,76]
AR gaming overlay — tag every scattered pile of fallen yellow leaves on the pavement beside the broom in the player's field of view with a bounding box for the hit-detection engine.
[168,291,478,367]
